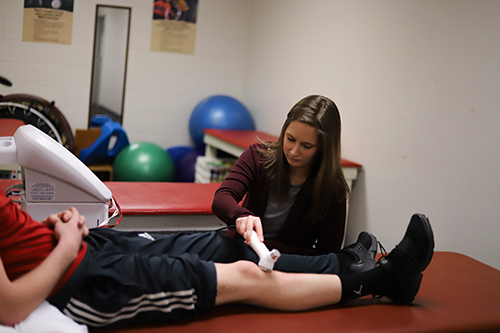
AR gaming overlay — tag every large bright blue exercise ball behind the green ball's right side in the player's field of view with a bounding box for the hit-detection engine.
[189,95,255,149]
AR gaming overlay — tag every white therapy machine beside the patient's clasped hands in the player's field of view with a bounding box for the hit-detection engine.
[0,125,113,228]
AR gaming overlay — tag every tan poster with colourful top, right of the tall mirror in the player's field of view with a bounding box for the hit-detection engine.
[151,0,198,54]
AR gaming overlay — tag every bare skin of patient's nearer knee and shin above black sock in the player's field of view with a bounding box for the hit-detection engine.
[215,261,342,311]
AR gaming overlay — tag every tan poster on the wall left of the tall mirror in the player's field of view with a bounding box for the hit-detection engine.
[23,0,74,44]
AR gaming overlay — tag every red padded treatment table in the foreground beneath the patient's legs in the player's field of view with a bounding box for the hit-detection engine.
[90,252,500,333]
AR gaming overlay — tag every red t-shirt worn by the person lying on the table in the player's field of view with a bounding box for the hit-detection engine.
[0,191,87,294]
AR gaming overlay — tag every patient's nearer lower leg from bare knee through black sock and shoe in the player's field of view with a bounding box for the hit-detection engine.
[215,214,434,311]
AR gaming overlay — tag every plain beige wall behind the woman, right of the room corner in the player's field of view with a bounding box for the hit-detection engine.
[244,0,500,268]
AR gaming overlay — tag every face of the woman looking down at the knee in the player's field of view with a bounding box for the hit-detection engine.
[283,120,318,169]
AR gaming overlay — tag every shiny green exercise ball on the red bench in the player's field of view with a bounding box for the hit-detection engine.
[113,142,175,182]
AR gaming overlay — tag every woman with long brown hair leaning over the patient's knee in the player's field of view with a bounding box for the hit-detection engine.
[212,95,358,254]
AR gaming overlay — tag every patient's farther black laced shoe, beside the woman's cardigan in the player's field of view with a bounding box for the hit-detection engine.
[342,231,378,274]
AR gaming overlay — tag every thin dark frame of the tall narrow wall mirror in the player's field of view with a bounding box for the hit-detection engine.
[87,4,132,127]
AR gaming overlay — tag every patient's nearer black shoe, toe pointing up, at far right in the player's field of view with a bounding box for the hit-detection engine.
[379,214,434,304]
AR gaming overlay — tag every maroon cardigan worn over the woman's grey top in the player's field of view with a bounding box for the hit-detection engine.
[212,143,346,255]
